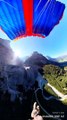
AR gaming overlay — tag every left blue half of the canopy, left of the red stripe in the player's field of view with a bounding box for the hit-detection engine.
[0,0,26,39]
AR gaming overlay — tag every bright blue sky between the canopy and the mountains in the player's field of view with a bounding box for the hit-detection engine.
[0,0,67,58]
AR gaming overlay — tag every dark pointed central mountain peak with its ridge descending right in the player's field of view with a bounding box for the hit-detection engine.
[24,52,63,70]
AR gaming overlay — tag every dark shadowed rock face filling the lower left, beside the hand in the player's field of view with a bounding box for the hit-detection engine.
[0,62,45,120]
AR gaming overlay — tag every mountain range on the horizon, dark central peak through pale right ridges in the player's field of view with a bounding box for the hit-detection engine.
[24,51,67,68]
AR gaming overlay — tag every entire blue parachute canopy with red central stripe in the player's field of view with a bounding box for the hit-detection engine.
[0,0,65,40]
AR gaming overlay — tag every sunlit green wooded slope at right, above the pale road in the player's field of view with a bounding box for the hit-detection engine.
[43,64,67,95]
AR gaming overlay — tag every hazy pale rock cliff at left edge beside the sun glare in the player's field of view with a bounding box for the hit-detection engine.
[0,38,22,65]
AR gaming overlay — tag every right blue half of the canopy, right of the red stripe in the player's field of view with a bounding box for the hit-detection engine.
[33,0,65,36]
